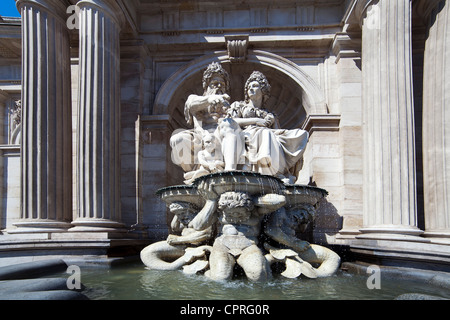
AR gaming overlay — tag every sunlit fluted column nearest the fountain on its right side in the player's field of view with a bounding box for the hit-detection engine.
[360,0,422,239]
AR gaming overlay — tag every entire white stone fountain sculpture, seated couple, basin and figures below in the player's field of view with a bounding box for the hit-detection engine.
[141,63,340,281]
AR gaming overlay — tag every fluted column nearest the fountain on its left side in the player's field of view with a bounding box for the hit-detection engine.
[71,0,123,231]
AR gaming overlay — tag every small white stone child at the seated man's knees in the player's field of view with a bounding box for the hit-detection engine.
[184,132,225,184]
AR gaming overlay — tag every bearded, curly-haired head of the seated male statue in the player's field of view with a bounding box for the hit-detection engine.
[202,62,230,94]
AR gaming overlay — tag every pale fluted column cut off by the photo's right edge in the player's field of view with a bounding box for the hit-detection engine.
[423,1,450,240]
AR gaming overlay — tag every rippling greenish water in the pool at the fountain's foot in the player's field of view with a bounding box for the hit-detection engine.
[81,263,450,300]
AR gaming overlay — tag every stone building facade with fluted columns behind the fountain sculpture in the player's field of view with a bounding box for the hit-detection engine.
[0,0,450,270]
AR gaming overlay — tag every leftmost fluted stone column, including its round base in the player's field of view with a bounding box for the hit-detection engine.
[8,0,72,233]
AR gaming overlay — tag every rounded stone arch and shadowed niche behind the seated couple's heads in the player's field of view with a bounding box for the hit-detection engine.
[153,50,327,129]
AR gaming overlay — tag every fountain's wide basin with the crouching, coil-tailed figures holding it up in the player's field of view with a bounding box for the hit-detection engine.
[149,171,332,281]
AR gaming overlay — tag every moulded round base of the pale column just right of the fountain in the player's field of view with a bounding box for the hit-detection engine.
[355,225,429,242]
